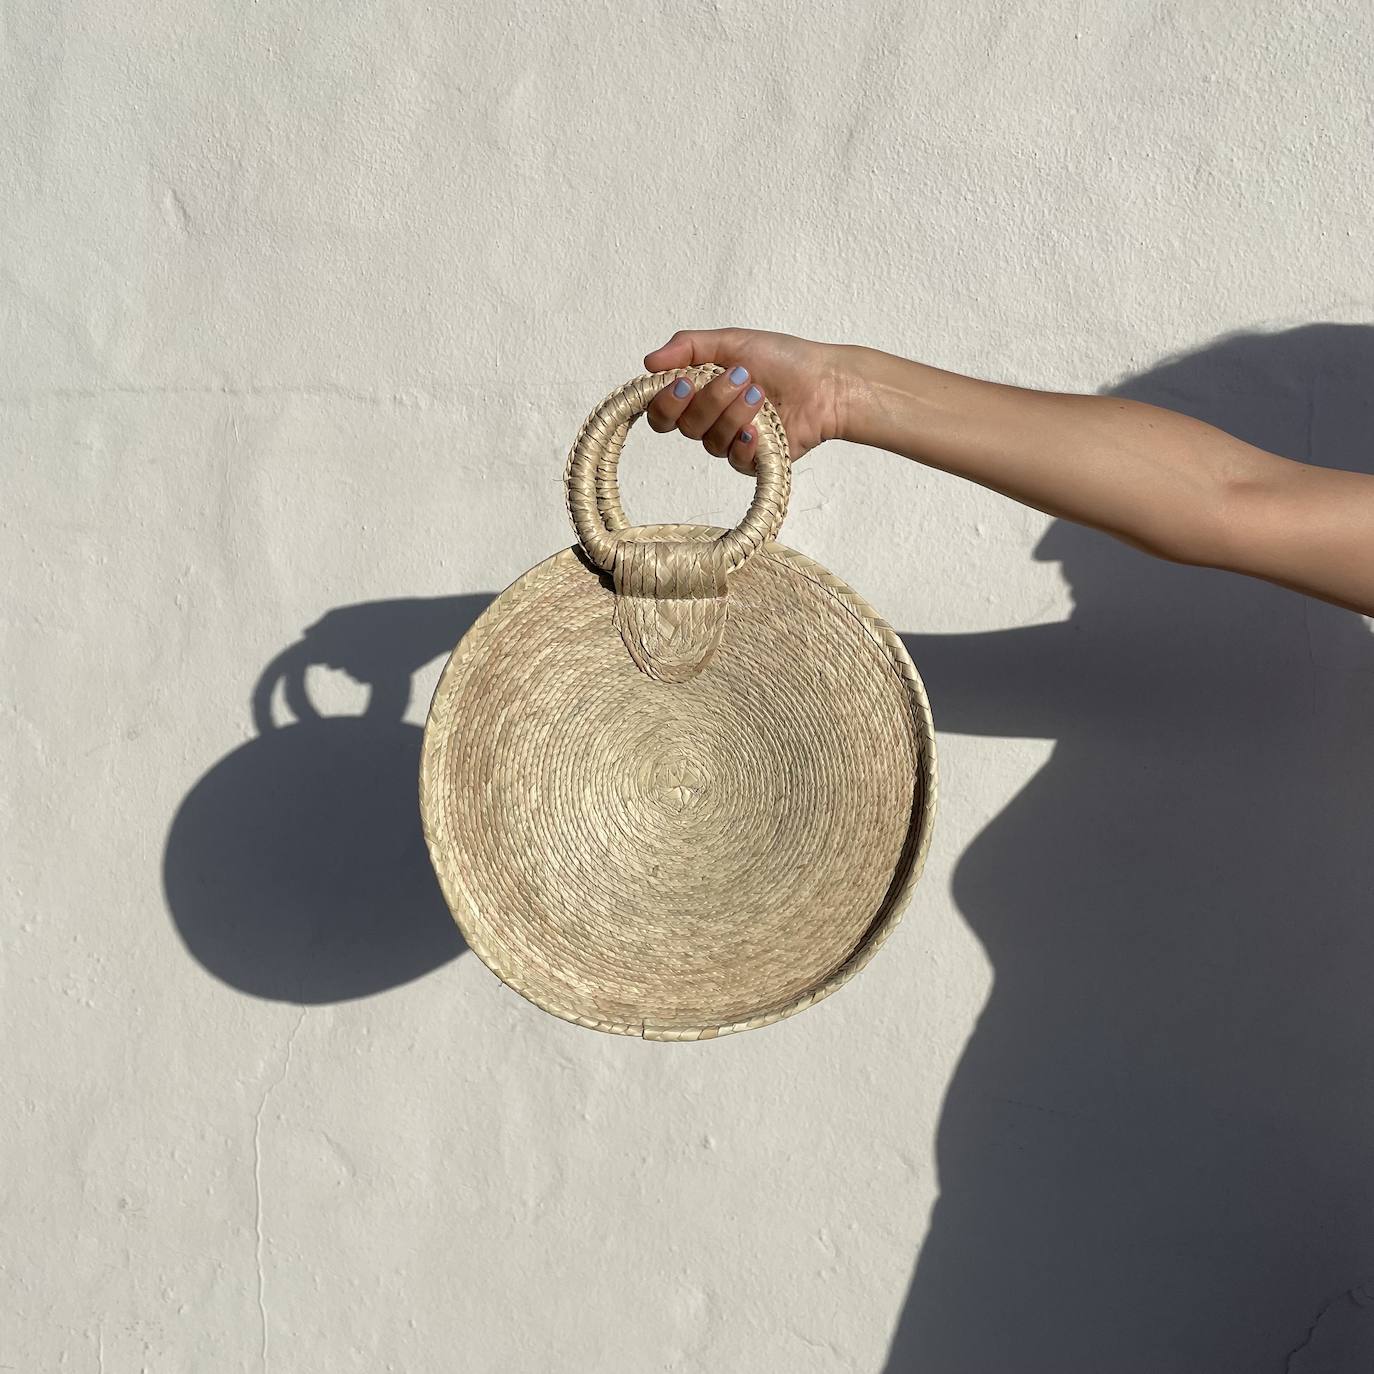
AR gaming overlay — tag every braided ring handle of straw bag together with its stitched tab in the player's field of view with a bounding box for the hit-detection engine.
[563,363,791,682]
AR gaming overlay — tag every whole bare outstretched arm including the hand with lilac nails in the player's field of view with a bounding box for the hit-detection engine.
[644,328,1374,616]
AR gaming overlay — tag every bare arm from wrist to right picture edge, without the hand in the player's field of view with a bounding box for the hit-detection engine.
[835,344,1374,616]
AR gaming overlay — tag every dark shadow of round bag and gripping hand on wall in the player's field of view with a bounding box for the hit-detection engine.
[164,595,491,1004]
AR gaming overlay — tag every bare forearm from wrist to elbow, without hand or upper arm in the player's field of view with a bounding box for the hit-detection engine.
[838,345,1287,567]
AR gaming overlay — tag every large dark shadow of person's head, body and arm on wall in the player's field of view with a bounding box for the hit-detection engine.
[886,326,1374,1374]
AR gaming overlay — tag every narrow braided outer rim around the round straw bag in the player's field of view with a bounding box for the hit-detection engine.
[419,523,938,1041]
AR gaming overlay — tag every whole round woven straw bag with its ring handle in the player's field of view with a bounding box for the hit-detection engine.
[420,364,936,1040]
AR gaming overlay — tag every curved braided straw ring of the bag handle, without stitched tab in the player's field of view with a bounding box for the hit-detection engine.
[565,363,791,572]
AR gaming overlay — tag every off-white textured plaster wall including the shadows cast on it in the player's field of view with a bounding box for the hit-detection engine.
[0,0,1374,1374]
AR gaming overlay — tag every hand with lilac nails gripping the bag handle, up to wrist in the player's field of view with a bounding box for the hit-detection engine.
[644,328,845,474]
